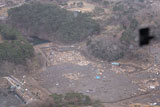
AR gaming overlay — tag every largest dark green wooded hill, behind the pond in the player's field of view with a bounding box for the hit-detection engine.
[8,2,100,43]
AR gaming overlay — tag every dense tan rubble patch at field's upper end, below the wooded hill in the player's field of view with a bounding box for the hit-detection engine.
[34,43,105,74]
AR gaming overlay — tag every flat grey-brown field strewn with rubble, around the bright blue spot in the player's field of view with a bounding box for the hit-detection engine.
[30,42,160,107]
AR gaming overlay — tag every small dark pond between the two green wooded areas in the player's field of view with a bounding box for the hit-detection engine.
[28,36,50,45]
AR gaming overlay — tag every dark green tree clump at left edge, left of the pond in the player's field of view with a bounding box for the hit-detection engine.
[0,25,34,64]
